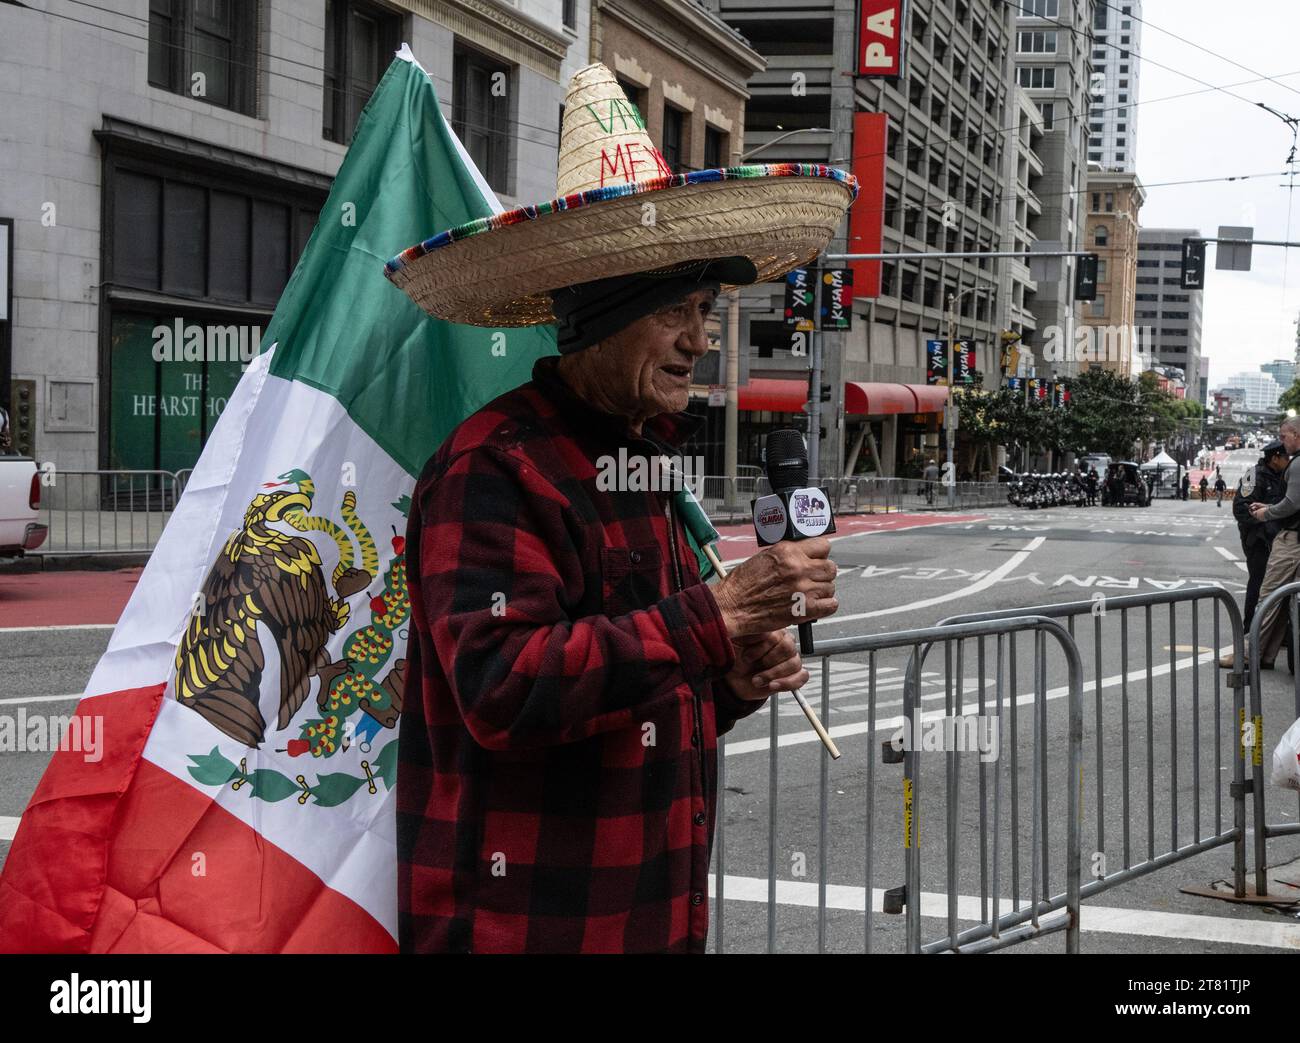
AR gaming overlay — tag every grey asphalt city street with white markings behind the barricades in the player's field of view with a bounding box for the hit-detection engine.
[0,478,1300,952]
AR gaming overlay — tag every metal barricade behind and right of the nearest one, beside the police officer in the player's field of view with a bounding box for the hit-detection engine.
[939,583,1253,897]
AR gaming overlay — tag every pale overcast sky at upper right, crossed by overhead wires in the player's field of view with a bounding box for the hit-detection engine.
[1138,0,1300,388]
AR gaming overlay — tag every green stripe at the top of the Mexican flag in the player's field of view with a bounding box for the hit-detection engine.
[263,51,555,476]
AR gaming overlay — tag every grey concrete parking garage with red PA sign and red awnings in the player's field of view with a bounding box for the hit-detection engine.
[719,0,1019,475]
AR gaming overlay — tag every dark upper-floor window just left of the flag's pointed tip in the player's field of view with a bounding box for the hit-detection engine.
[321,0,402,144]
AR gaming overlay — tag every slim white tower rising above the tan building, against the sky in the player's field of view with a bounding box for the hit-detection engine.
[1088,0,1143,173]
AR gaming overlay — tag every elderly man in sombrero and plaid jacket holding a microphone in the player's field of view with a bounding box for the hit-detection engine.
[386,62,857,952]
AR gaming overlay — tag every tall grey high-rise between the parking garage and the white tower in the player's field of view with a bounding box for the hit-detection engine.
[1011,0,1095,376]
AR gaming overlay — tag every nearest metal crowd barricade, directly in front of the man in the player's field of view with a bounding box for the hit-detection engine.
[712,616,1083,952]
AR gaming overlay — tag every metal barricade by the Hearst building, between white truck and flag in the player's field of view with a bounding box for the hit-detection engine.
[40,469,189,555]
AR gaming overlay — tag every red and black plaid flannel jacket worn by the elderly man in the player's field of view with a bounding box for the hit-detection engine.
[398,356,761,952]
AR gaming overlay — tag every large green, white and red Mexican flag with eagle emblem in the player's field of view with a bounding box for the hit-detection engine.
[0,46,555,952]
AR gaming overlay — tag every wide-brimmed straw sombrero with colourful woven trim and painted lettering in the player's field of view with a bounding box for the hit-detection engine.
[385,62,858,326]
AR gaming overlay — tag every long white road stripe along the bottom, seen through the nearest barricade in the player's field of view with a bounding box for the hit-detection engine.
[709,874,1300,949]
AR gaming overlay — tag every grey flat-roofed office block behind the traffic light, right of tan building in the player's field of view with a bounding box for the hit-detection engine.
[1134,228,1206,402]
